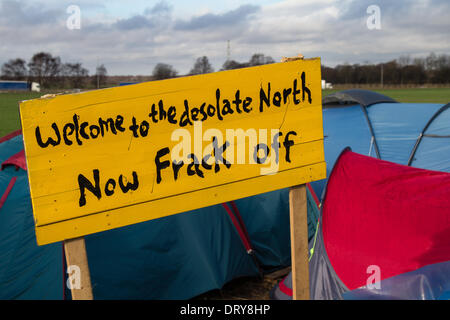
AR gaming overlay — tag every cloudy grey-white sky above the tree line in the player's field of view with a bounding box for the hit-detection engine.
[0,0,450,75]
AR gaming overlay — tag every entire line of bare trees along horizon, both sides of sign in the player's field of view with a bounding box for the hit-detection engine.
[7,52,450,89]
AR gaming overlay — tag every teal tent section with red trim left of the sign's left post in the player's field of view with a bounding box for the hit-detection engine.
[0,132,63,299]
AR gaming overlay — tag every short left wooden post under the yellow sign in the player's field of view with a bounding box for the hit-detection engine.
[64,238,94,300]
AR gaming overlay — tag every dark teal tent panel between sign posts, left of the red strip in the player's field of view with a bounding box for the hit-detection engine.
[86,206,260,299]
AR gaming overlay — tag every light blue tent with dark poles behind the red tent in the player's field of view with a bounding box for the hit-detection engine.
[311,89,450,195]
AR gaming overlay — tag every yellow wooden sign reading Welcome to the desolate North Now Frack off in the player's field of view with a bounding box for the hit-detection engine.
[20,58,326,245]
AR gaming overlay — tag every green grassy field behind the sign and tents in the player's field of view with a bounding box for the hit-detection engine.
[0,88,450,137]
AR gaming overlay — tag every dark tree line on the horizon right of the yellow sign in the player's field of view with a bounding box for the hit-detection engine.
[322,53,450,85]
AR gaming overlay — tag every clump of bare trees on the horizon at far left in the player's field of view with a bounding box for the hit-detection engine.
[1,52,107,89]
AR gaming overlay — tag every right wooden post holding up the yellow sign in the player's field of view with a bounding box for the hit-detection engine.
[289,184,309,300]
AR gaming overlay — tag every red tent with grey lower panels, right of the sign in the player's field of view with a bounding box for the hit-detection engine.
[273,149,450,299]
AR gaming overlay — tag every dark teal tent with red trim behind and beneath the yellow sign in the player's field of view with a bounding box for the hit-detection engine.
[0,132,318,299]
